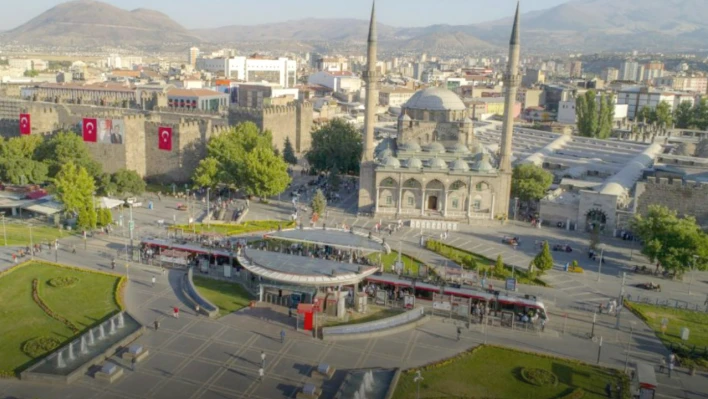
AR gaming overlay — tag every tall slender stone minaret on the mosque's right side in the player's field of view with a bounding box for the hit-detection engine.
[497,3,521,219]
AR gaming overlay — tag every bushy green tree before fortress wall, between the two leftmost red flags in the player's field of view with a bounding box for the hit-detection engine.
[36,132,102,178]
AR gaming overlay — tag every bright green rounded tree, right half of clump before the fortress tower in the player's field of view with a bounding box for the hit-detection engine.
[242,147,291,198]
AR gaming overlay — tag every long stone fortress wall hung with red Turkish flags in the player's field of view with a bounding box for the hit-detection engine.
[0,97,313,183]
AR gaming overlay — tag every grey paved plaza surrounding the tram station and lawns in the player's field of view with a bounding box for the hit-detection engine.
[0,190,708,399]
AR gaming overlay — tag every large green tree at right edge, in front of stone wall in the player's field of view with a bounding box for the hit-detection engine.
[631,205,708,275]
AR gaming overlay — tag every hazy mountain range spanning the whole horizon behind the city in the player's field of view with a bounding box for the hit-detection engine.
[0,0,708,53]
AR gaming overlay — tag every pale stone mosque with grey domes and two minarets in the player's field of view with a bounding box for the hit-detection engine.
[359,3,520,222]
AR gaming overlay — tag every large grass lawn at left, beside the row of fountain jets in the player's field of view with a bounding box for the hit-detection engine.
[0,262,119,372]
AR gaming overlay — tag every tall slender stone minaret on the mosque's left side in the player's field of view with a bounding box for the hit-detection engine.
[359,1,379,213]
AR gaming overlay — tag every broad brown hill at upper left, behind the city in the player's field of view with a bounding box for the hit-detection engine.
[0,0,199,47]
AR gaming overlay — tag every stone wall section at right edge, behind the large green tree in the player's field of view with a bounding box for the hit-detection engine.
[635,177,708,226]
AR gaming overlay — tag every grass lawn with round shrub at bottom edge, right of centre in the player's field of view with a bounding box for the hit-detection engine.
[393,346,629,399]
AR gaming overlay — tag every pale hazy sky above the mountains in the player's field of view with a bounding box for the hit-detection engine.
[0,0,576,30]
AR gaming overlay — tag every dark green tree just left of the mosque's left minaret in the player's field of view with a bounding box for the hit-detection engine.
[306,119,363,174]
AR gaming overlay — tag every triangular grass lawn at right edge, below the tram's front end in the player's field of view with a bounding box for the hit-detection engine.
[625,302,708,368]
